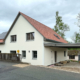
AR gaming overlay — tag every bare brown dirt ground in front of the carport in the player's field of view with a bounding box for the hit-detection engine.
[50,62,80,73]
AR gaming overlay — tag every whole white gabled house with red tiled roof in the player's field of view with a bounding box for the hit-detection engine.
[0,12,80,66]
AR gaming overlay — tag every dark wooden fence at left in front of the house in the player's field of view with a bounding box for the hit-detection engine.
[0,53,21,62]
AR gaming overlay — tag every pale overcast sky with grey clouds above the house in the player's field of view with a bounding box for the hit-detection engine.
[0,0,80,41]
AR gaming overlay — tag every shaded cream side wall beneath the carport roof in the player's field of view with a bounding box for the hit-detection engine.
[44,47,67,65]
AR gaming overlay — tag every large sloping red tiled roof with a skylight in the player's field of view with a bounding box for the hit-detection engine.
[19,12,68,43]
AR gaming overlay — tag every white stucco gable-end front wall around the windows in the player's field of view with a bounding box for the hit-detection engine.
[0,15,44,65]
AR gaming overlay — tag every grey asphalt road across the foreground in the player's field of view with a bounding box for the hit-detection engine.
[0,62,80,80]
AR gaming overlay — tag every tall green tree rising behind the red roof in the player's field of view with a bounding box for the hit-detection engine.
[53,11,69,39]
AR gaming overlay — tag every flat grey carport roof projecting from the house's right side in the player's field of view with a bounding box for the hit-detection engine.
[44,43,80,48]
